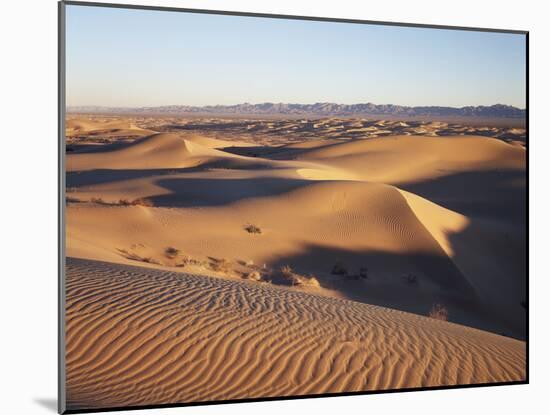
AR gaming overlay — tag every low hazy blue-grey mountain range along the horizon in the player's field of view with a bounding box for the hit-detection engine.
[67,102,525,118]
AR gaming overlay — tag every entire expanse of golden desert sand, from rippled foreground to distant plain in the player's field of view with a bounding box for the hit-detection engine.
[66,117,526,408]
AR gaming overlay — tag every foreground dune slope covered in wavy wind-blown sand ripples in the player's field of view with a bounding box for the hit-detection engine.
[66,259,525,409]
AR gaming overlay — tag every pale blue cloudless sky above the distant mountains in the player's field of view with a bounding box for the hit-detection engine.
[66,5,525,108]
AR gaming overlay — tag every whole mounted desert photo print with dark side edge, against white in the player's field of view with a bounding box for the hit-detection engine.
[60,2,528,412]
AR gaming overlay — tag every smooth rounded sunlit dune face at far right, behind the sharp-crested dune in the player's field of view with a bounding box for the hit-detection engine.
[297,136,525,184]
